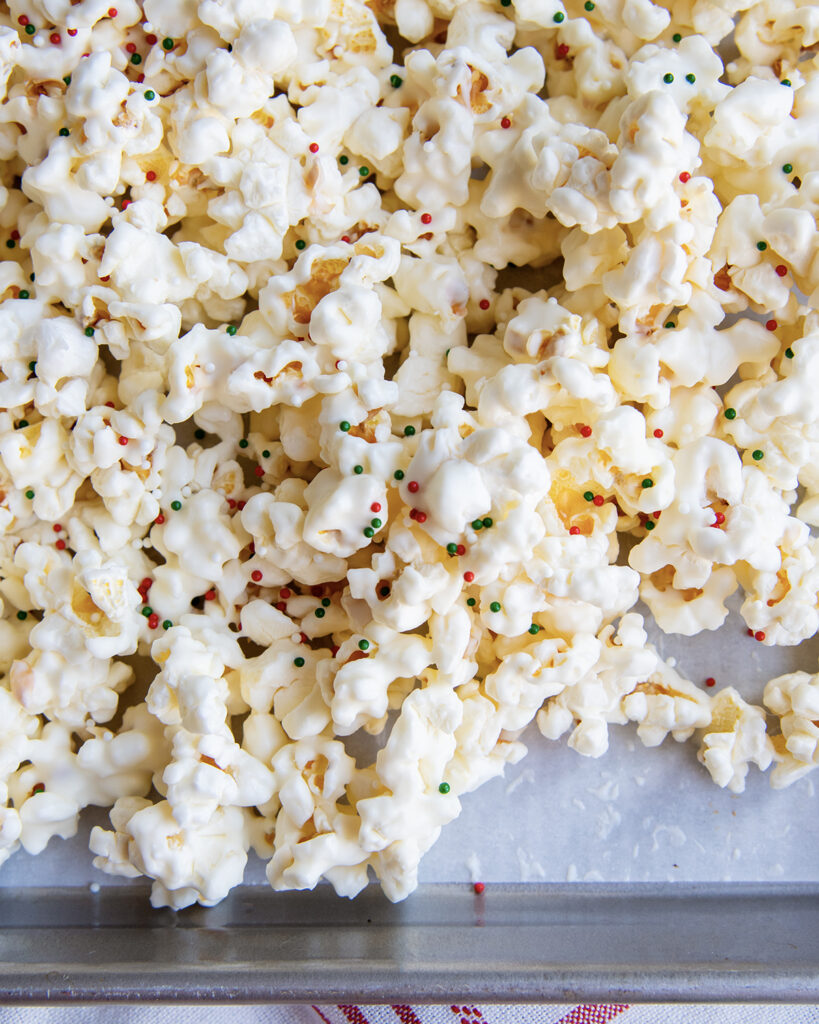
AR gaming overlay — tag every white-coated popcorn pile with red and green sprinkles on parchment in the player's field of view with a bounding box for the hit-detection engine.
[0,0,819,907]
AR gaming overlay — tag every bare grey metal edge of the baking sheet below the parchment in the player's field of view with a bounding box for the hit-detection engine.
[0,883,819,1004]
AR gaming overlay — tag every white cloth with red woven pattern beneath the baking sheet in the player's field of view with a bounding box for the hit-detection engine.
[0,1002,819,1024]
